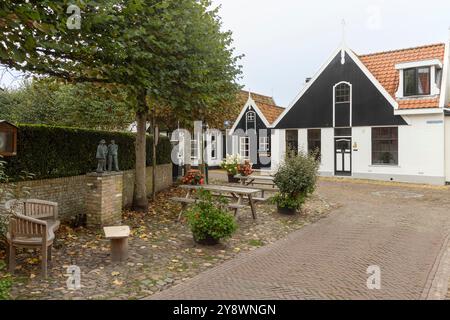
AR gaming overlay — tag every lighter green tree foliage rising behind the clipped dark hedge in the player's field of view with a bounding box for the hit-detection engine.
[0,78,134,130]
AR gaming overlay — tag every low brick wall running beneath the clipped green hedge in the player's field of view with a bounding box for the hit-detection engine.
[1,164,172,221]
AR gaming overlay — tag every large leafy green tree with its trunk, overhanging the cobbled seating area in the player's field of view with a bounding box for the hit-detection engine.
[0,0,240,210]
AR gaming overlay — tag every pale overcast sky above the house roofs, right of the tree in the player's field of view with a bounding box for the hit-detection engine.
[213,0,450,107]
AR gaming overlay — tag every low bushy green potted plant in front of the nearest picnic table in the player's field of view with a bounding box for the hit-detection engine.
[186,190,237,245]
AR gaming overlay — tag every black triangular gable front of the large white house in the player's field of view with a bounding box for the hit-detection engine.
[275,53,407,129]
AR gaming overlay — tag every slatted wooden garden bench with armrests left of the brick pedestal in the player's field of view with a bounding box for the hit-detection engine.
[5,199,60,278]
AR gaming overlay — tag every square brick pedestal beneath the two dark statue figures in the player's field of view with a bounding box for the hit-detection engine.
[86,172,123,228]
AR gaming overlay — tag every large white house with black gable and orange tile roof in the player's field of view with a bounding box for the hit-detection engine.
[271,43,450,185]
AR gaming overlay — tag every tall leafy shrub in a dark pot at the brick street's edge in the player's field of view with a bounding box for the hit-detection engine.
[272,152,319,214]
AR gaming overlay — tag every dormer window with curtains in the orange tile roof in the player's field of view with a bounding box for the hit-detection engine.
[403,67,431,97]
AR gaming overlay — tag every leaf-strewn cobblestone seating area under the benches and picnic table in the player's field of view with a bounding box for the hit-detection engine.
[0,182,331,299]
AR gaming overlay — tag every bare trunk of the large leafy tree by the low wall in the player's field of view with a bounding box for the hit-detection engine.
[133,102,148,212]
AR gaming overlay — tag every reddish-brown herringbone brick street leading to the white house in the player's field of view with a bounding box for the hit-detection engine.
[150,181,450,300]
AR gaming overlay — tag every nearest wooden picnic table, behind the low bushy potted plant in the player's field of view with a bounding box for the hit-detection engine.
[172,185,261,220]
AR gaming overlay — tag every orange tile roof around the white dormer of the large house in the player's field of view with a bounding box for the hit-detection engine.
[359,43,445,109]
